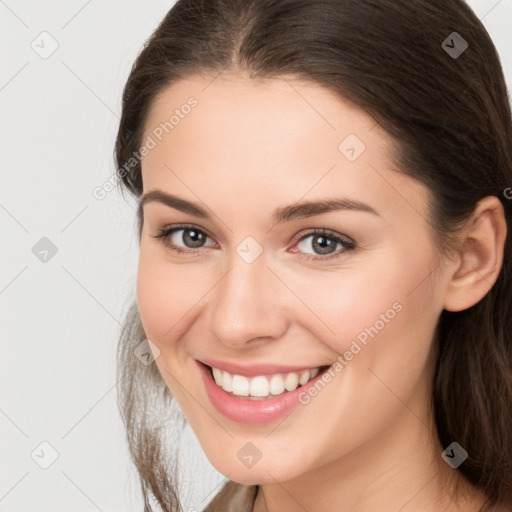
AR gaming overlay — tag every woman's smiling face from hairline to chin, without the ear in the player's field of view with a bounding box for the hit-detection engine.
[137,74,447,484]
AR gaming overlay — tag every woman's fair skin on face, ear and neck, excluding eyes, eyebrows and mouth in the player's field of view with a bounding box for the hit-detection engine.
[137,73,506,512]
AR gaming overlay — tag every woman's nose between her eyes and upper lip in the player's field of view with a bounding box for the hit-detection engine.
[209,253,291,348]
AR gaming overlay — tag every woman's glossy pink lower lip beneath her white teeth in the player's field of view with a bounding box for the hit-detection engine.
[196,361,328,425]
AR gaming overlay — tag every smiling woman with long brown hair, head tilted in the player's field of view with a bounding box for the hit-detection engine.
[115,0,512,512]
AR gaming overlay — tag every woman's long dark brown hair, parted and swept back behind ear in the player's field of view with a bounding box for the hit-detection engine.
[115,0,512,512]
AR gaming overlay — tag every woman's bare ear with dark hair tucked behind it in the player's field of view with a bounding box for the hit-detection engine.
[444,196,507,311]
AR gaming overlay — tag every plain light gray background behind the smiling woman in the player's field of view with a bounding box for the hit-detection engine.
[0,0,512,512]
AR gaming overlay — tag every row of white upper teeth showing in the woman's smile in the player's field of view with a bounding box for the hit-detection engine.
[212,367,320,400]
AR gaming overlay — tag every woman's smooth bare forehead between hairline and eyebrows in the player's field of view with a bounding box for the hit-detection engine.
[138,74,430,224]
